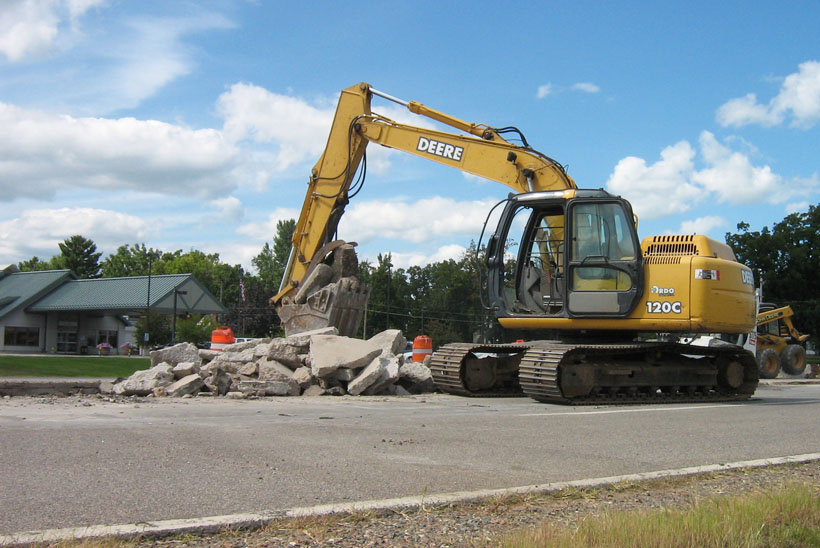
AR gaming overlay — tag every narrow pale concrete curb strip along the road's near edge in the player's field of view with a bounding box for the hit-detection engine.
[0,453,820,546]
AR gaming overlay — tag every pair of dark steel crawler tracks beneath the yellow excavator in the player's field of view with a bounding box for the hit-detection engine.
[430,341,758,405]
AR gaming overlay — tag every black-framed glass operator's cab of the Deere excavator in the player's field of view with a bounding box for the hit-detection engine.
[487,190,643,318]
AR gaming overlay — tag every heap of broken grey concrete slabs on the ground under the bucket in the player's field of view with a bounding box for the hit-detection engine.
[113,327,442,398]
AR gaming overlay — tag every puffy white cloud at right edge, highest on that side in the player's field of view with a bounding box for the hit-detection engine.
[716,61,820,128]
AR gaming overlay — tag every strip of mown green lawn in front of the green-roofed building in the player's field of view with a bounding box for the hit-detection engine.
[0,356,151,378]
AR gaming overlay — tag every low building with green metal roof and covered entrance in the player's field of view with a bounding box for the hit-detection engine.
[0,267,228,354]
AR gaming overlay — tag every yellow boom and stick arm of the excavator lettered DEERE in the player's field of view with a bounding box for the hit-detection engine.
[271,83,576,315]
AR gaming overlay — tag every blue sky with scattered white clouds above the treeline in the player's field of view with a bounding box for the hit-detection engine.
[0,0,820,274]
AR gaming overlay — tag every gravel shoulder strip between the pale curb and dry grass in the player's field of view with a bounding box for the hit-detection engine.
[137,461,820,548]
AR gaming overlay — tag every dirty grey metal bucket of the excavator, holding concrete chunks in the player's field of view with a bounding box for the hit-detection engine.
[277,278,370,337]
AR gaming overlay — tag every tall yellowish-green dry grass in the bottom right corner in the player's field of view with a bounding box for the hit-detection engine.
[502,485,820,548]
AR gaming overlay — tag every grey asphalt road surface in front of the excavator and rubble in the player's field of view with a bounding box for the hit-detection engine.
[0,384,820,534]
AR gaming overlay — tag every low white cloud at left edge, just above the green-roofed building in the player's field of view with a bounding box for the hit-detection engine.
[0,207,161,263]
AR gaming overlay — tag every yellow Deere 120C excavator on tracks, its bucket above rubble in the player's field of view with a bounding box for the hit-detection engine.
[271,83,758,404]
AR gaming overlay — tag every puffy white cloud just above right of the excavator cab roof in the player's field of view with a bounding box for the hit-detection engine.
[606,141,702,219]
